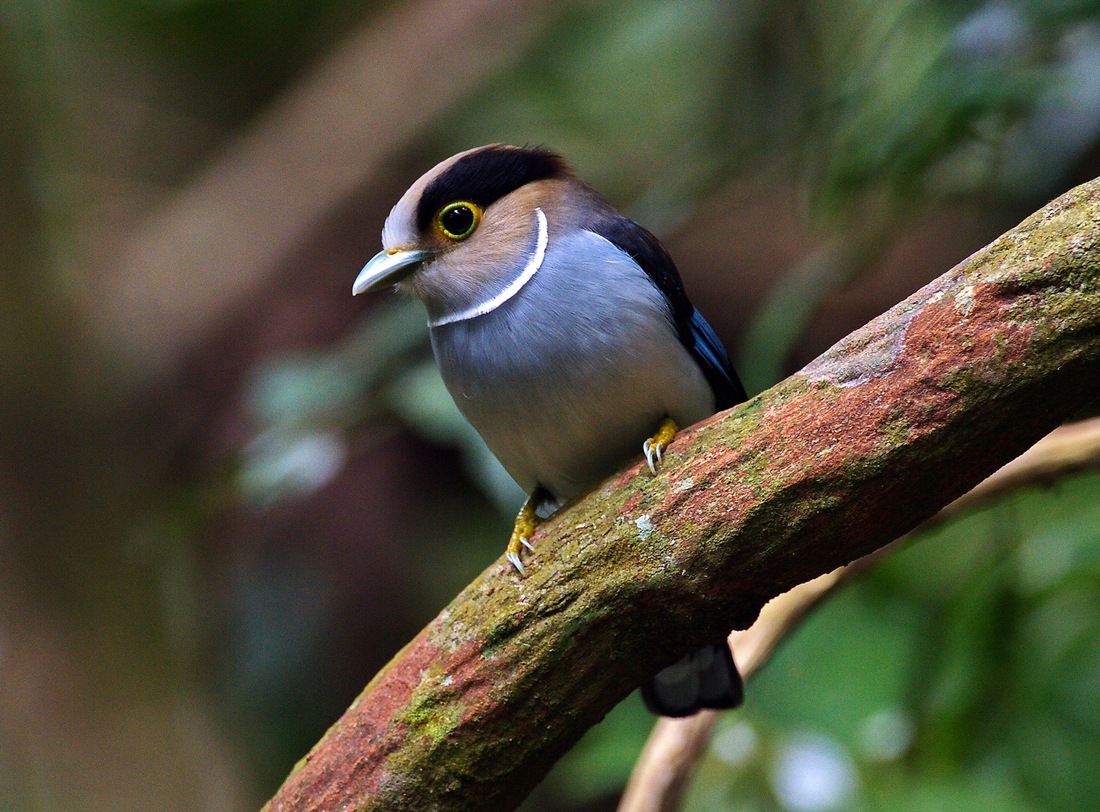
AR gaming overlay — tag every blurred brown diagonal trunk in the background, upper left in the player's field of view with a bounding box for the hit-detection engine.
[88,0,554,374]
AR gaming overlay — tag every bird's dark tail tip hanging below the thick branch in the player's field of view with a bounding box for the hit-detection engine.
[641,640,745,716]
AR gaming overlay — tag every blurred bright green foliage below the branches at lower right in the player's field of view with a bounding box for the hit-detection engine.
[688,474,1100,812]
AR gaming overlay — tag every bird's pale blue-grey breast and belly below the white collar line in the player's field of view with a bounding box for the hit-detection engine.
[431,226,714,492]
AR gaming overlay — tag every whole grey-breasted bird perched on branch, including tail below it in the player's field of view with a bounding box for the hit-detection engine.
[352,144,747,716]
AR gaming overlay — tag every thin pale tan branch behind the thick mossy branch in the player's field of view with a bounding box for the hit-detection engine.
[618,417,1100,812]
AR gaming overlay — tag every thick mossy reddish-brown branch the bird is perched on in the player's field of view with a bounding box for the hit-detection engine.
[267,182,1100,810]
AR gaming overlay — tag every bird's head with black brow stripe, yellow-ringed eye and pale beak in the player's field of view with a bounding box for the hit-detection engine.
[352,144,595,319]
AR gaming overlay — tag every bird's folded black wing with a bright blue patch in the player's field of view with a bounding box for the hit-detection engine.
[590,212,748,412]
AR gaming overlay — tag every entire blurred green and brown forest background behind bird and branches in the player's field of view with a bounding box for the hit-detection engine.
[0,0,1100,812]
